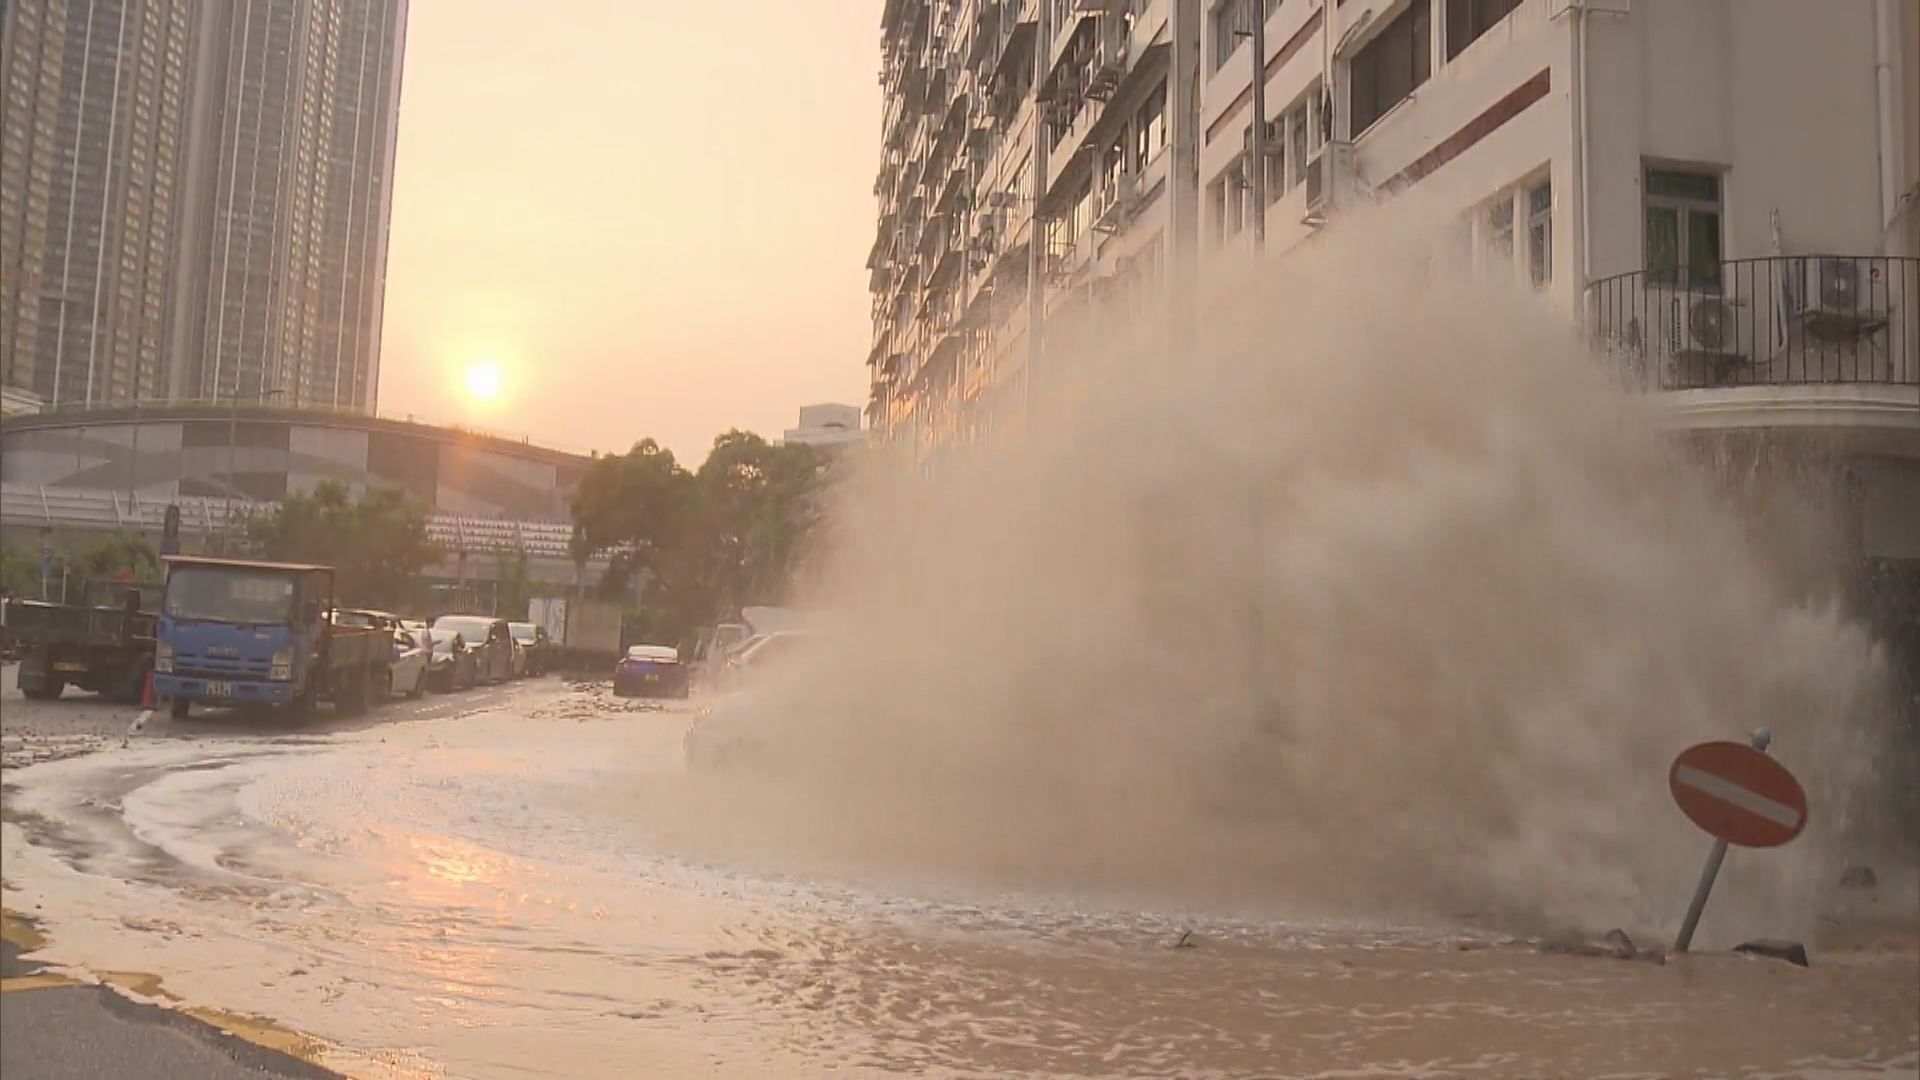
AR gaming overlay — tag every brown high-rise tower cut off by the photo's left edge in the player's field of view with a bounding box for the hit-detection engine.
[0,0,198,405]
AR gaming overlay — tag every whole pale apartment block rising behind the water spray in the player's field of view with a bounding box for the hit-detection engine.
[868,0,1920,459]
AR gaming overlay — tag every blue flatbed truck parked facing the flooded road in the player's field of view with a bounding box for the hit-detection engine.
[154,555,394,719]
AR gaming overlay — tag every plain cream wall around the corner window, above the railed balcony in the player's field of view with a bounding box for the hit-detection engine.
[1588,0,1882,277]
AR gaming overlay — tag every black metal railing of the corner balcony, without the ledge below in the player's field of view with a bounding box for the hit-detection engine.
[1586,256,1920,390]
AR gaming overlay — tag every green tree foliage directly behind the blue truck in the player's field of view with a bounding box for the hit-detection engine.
[248,480,442,609]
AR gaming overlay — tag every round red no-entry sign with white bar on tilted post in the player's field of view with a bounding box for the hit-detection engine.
[1667,742,1807,847]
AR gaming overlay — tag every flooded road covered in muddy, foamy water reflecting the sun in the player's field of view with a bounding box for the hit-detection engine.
[4,682,1920,1078]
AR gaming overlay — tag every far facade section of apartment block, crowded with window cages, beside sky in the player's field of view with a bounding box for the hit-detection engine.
[868,0,1198,452]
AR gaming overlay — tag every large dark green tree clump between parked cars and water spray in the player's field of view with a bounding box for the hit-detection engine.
[574,430,828,640]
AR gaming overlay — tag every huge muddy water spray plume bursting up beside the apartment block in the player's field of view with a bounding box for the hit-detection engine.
[687,201,1884,930]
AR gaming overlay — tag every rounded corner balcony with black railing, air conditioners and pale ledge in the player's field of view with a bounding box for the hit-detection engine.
[1586,256,1920,447]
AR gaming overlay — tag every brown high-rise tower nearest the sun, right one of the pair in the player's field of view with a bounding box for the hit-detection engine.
[171,0,407,413]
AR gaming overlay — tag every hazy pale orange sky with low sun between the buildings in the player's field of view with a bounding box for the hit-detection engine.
[380,0,881,463]
